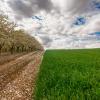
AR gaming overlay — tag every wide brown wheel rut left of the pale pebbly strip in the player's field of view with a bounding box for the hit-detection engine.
[0,53,37,91]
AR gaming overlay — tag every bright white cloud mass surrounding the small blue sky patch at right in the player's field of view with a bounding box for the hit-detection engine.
[0,0,100,48]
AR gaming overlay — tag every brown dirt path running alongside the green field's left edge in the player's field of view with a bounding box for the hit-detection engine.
[0,52,43,100]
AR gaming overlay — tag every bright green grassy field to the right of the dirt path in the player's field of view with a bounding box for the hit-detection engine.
[35,49,100,100]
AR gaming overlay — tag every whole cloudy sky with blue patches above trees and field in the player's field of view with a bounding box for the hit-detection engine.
[0,0,100,49]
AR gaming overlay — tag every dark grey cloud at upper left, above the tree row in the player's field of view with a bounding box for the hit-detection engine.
[8,0,52,19]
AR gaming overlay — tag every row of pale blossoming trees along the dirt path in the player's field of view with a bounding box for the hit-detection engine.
[0,15,43,53]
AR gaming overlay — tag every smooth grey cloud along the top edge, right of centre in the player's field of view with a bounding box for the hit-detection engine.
[52,0,93,14]
